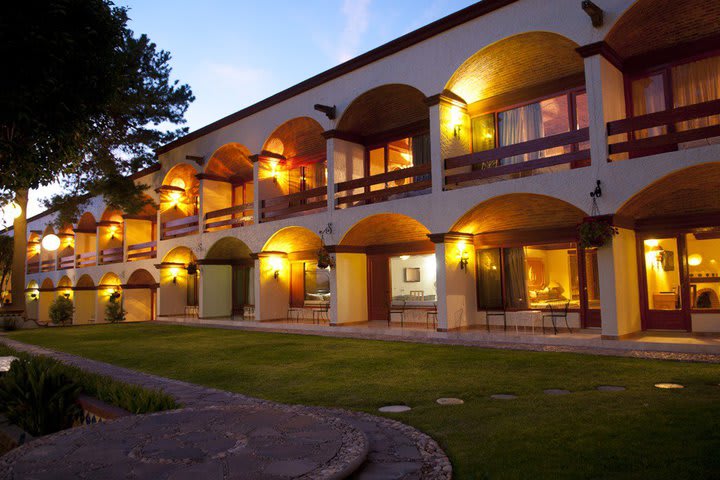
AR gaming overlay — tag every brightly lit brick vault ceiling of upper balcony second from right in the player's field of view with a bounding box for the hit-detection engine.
[445,31,584,104]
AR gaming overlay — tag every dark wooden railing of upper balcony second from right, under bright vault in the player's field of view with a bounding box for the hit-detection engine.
[445,128,590,186]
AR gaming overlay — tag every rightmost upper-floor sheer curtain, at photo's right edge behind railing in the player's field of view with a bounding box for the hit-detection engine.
[672,57,720,136]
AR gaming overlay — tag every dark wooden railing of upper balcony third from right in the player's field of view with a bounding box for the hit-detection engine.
[335,163,432,208]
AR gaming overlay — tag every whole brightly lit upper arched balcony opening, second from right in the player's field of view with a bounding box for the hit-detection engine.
[440,32,590,187]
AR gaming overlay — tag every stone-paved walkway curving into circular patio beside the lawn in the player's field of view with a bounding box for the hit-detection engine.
[0,337,452,480]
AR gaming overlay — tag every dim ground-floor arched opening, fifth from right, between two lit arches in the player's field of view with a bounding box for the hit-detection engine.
[198,237,255,318]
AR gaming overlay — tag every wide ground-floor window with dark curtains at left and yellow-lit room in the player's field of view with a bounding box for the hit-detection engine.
[476,243,599,310]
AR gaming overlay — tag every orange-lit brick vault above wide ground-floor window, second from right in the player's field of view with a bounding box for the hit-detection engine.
[451,193,586,234]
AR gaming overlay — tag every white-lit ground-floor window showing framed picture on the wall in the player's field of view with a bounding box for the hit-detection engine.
[390,253,437,302]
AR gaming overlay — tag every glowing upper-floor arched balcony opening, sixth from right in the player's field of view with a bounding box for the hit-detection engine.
[156,163,200,240]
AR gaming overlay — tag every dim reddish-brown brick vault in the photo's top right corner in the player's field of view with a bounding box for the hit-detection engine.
[605,0,720,58]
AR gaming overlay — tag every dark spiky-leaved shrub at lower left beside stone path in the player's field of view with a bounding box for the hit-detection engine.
[0,357,81,436]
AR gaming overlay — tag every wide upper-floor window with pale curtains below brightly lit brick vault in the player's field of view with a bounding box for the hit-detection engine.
[471,90,588,168]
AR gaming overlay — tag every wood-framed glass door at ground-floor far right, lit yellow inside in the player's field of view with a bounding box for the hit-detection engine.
[638,236,690,330]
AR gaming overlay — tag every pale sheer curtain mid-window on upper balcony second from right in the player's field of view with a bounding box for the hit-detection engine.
[498,103,543,165]
